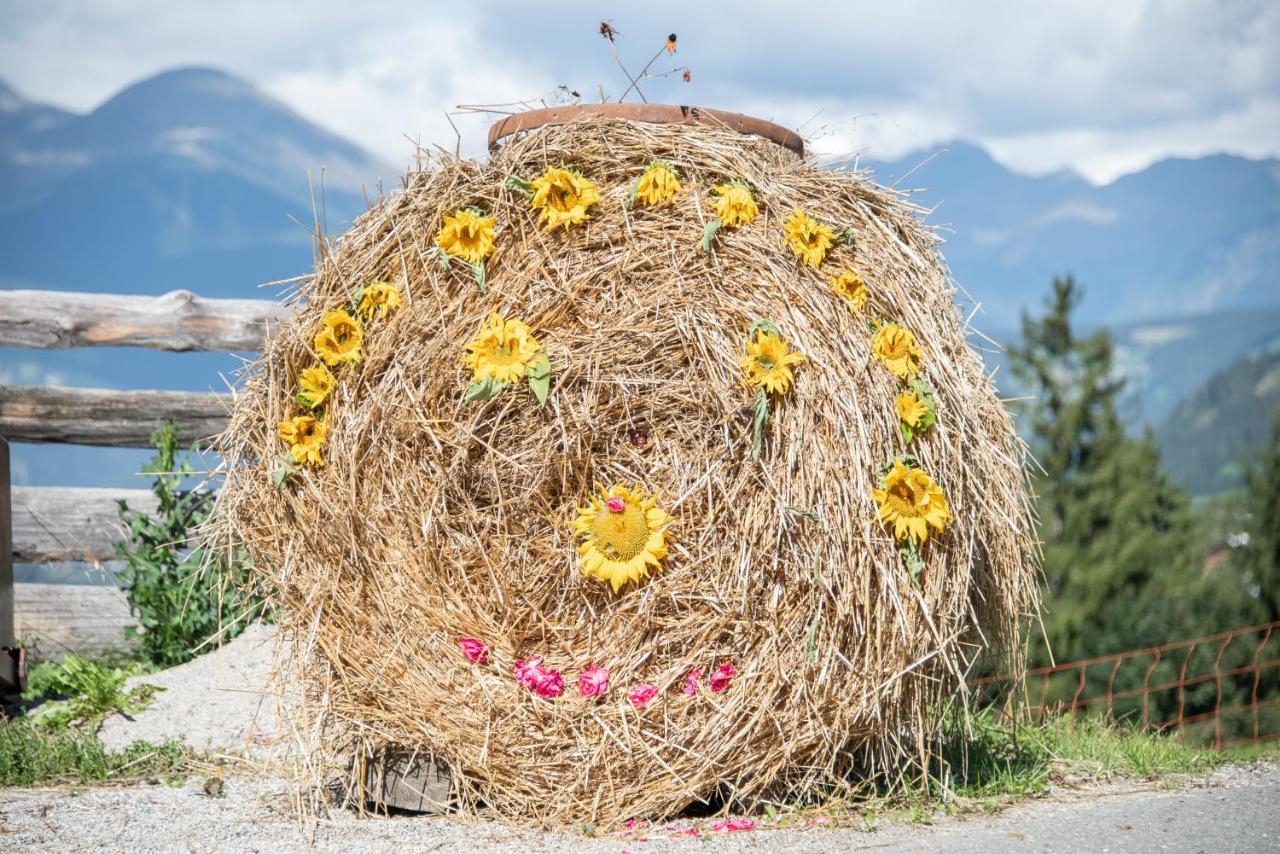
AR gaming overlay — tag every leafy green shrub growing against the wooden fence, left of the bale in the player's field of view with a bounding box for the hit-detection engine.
[116,424,261,667]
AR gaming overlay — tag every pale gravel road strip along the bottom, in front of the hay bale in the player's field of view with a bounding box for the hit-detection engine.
[0,764,1280,854]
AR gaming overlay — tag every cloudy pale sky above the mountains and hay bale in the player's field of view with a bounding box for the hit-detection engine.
[0,0,1280,182]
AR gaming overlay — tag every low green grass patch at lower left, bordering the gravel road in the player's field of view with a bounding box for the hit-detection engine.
[0,717,189,787]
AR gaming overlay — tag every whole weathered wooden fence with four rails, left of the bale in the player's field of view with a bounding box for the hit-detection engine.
[0,291,288,649]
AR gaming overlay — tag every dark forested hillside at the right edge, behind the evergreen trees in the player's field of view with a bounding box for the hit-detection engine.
[1156,346,1280,494]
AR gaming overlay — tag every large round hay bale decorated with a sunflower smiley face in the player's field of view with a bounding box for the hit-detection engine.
[219,110,1037,822]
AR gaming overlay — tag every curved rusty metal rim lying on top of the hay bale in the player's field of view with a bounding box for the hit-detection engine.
[489,104,804,156]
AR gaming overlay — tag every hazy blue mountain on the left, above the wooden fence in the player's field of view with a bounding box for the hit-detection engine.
[0,68,392,280]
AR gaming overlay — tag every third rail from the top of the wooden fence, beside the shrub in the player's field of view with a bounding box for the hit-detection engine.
[12,487,156,563]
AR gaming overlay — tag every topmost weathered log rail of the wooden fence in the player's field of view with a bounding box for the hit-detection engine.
[0,291,291,352]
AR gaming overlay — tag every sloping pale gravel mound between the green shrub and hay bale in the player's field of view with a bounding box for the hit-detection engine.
[99,624,279,753]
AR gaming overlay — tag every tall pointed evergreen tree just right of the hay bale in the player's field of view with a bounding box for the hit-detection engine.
[1009,277,1239,663]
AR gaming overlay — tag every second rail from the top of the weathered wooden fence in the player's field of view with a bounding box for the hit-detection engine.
[0,385,228,448]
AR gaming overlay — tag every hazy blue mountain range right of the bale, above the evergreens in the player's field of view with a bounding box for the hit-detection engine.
[863,142,1280,326]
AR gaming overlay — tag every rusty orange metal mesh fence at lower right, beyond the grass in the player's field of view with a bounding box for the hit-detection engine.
[974,621,1280,748]
